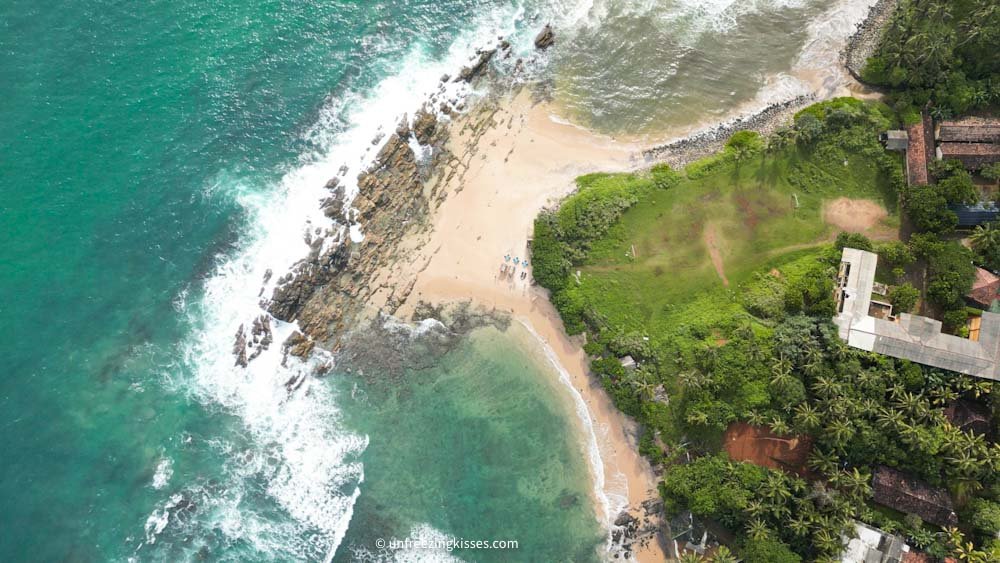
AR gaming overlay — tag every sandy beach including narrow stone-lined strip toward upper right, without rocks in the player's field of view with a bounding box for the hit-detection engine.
[370,6,892,561]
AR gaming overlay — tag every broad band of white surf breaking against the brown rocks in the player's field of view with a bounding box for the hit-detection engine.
[142,3,608,561]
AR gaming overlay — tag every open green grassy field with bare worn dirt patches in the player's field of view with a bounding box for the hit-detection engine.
[567,144,898,348]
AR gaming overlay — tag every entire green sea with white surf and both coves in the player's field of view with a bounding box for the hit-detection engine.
[0,0,865,561]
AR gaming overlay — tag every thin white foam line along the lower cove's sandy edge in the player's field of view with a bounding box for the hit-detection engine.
[518,318,628,553]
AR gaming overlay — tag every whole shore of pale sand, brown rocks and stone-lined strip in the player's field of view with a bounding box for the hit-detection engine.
[260,0,908,561]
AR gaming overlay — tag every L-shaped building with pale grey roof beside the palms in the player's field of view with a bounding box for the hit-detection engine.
[833,248,1000,380]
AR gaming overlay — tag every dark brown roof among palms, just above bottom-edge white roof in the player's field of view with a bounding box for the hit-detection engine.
[872,465,958,527]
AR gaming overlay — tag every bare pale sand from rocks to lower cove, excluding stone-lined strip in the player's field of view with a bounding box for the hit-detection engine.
[373,92,665,561]
